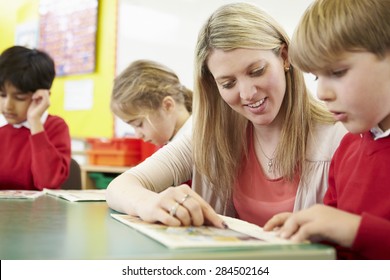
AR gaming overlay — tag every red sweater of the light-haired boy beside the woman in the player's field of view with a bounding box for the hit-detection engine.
[324,132,390,259]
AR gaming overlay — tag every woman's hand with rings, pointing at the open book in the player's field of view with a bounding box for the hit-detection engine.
[136,185,226,228]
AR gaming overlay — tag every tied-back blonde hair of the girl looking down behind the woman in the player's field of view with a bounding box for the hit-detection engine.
[111,60,192,119]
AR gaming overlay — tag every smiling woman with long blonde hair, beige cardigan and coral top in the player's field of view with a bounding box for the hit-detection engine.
[107,3,345,227]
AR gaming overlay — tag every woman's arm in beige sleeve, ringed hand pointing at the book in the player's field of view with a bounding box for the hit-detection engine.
[106,136,223,227]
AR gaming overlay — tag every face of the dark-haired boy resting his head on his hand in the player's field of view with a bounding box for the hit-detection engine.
[0,82,32,124]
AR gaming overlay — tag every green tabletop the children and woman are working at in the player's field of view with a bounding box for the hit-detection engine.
[0,195,335,260]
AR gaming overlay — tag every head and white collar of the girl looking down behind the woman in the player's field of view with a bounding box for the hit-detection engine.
[111,60,192,146]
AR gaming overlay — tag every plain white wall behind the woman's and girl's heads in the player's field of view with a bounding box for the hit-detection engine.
[117,0,313,88]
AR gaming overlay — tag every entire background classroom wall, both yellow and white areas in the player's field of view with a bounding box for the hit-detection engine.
[0,0,316,138]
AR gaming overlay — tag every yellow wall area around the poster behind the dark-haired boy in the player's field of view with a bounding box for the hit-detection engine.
[0,0,117,138]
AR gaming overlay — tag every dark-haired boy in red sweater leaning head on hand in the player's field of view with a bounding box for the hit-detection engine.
[0,46,70,190]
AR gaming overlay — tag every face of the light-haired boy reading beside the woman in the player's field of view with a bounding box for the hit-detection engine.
[313,52,390,133]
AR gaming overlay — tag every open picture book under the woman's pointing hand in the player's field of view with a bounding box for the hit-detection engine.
[111,214,291,248]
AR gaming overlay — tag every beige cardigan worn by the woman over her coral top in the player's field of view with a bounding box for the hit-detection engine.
[127,123,346,216]
